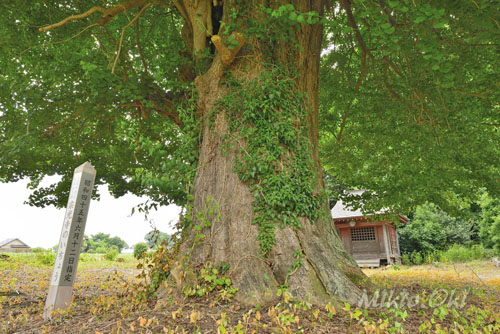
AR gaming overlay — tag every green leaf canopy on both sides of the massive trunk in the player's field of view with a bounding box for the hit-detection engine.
[0,0,500,211]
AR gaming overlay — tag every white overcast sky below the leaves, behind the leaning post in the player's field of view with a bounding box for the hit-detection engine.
[0,178,180,248]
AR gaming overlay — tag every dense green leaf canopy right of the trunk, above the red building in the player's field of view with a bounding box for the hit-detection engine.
[320,0,500,212]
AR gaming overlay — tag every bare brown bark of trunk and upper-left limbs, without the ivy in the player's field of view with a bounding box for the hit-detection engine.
[33,0,366,304]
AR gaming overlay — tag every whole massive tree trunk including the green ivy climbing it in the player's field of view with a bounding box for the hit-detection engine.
[168,1,363,303]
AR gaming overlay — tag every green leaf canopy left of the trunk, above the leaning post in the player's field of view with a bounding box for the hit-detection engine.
[0,1,197,207]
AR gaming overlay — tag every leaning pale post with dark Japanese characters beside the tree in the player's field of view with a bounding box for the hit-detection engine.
[43,162,96,320]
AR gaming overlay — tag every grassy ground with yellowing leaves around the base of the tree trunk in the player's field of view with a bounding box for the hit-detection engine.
[0,254,500,333]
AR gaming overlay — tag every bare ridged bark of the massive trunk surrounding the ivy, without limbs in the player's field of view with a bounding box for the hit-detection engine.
[172,0,365,304]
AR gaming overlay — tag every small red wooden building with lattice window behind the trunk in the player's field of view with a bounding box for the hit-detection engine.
[332,190,408,267]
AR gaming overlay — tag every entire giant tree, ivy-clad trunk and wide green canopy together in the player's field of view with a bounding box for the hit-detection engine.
[0,0,500,303]
